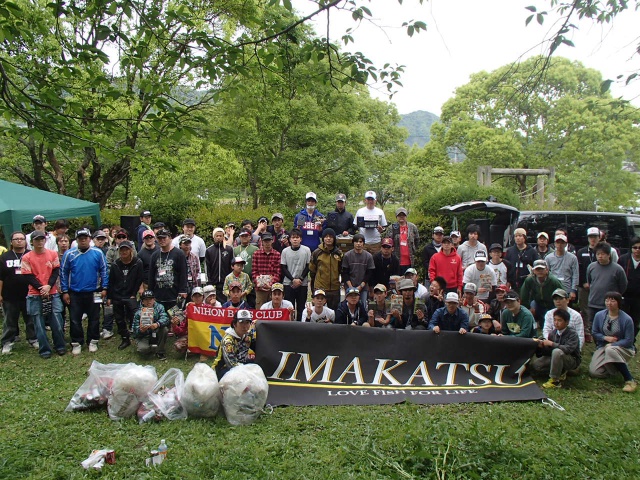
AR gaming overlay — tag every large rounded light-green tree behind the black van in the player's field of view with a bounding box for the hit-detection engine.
[434,57,640,210]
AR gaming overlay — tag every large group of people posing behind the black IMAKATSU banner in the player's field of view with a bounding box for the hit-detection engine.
[0,197,640,392]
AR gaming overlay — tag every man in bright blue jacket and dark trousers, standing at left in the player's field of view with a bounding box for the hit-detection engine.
[60,228,109,355]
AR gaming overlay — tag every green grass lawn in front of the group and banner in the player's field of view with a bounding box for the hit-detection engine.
[0,332,640,480]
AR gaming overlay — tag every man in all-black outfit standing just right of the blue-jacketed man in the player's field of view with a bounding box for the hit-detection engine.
[107,240,144,350]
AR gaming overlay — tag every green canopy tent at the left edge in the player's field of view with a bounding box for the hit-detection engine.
[0,180,100,246]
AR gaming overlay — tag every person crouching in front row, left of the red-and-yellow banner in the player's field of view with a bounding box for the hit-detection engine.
[133,290,171,360]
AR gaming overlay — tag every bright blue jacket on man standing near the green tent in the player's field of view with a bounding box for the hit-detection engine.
[60,247,109,293]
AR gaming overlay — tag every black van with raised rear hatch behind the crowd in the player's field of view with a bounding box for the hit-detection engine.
[439,201,640,254]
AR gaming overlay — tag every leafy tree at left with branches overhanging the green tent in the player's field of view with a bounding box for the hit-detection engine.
[0,0,426,206]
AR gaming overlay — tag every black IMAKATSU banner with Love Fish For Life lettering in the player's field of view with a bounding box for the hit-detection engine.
[256,321,546,406]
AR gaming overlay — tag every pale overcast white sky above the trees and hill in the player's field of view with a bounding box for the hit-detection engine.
[292,0,640,115]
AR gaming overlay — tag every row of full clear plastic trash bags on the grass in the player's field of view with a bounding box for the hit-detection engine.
[65,360,269,425]
